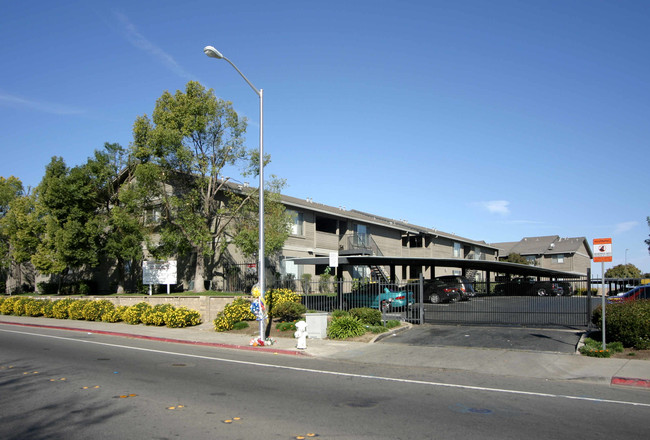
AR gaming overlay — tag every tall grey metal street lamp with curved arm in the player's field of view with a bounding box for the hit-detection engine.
[203,46,266,341]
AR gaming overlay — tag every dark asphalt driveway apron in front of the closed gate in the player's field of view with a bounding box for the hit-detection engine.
[380,324,584,353]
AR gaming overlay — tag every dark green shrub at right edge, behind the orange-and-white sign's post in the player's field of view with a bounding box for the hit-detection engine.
[592,300,650,350]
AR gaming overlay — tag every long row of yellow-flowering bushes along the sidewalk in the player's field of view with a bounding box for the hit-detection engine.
[0,296,201,328]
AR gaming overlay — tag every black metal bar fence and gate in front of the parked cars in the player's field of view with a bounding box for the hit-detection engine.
[214,274,599,327]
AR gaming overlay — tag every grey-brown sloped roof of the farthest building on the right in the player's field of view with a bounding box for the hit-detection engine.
[492,235,593,258]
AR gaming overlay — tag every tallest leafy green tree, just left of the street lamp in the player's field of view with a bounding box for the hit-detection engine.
[132,81,288,291]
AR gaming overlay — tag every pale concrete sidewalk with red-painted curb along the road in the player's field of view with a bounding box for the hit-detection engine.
[0,315,650,390]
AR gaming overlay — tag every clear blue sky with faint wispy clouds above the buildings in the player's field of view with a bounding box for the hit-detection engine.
[0,0,650,274]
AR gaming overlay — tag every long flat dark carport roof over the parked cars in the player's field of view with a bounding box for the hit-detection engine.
[290,255,584,278]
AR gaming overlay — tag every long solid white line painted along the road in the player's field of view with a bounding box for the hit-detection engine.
[0,329,650,408]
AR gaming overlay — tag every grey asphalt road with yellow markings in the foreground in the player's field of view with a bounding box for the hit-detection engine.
[0,329,650,440]
